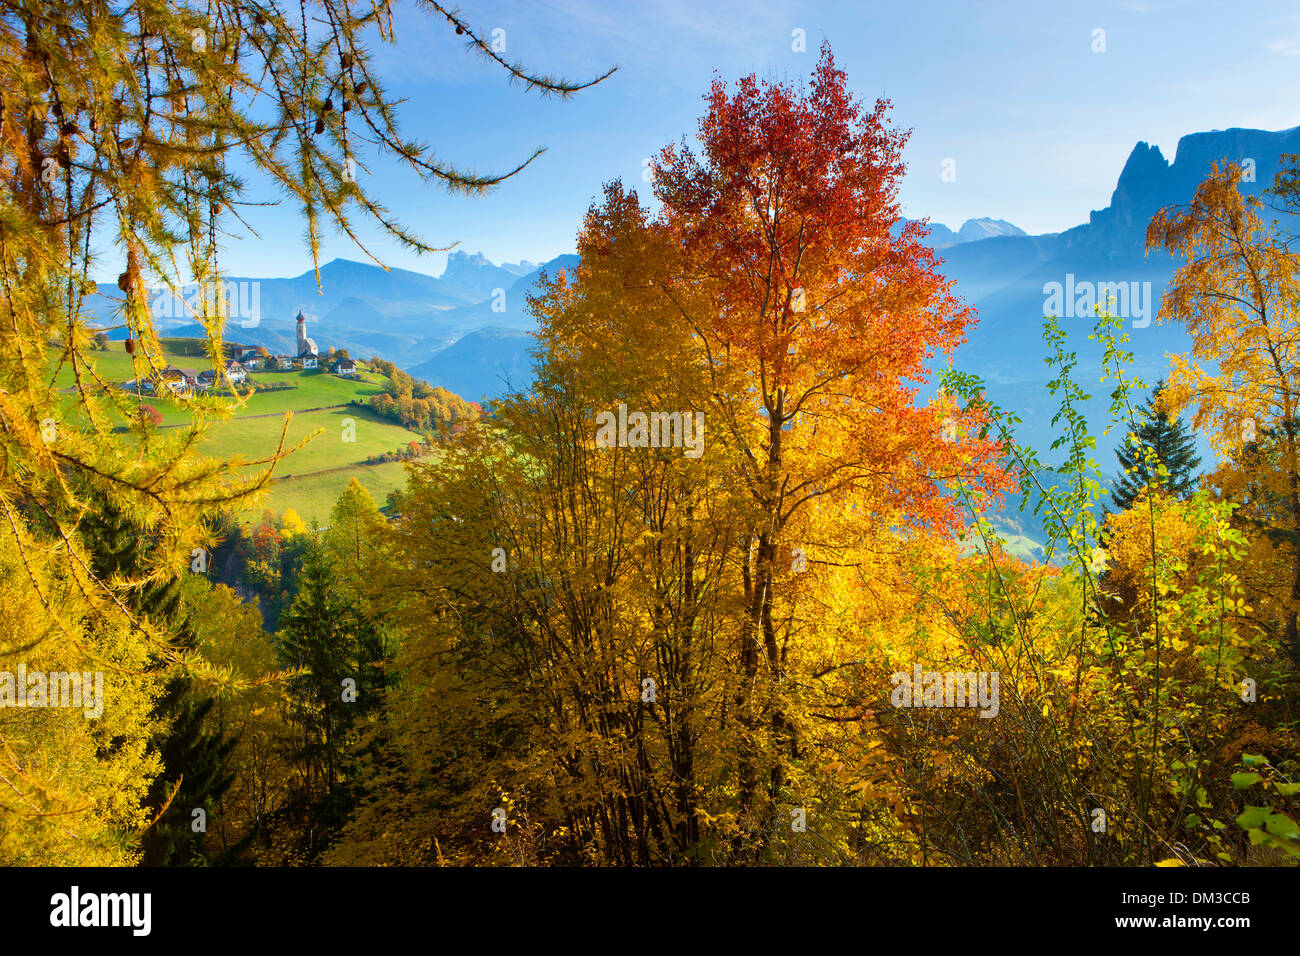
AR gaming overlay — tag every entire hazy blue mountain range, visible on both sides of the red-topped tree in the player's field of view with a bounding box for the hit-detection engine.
[87,127,1300,468]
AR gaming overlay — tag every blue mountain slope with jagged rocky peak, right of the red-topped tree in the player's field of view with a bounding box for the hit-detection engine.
[940,127,1300,470]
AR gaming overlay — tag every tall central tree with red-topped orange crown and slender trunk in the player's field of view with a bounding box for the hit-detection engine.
[655,46,1013,842]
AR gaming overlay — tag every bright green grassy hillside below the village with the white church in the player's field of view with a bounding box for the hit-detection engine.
[55,341,420,524]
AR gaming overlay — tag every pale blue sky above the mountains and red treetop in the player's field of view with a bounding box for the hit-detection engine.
[197,0,1300,282]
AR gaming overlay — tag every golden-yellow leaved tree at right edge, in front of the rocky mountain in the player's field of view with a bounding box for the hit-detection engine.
[1147,164,1300,666]
